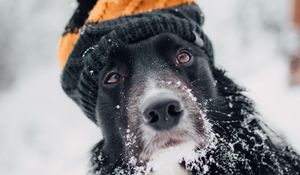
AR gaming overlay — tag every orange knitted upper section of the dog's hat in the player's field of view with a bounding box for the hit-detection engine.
[58,0,193,67]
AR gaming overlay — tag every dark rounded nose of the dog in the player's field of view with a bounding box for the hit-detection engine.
[143,98,184,130]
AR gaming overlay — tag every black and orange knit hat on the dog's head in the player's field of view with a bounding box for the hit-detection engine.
[58,0,213,123]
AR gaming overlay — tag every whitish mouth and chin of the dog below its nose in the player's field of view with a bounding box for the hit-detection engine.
[139,116,208,162]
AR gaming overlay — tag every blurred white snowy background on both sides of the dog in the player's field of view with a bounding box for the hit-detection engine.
[0,0,300,175]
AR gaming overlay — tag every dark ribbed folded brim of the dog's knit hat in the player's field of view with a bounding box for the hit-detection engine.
[61,1,213,123]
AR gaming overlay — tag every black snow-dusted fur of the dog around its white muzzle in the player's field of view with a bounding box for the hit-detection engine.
[87,34,300,175]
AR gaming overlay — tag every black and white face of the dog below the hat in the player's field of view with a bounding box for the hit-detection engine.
[97,34,217,166]
